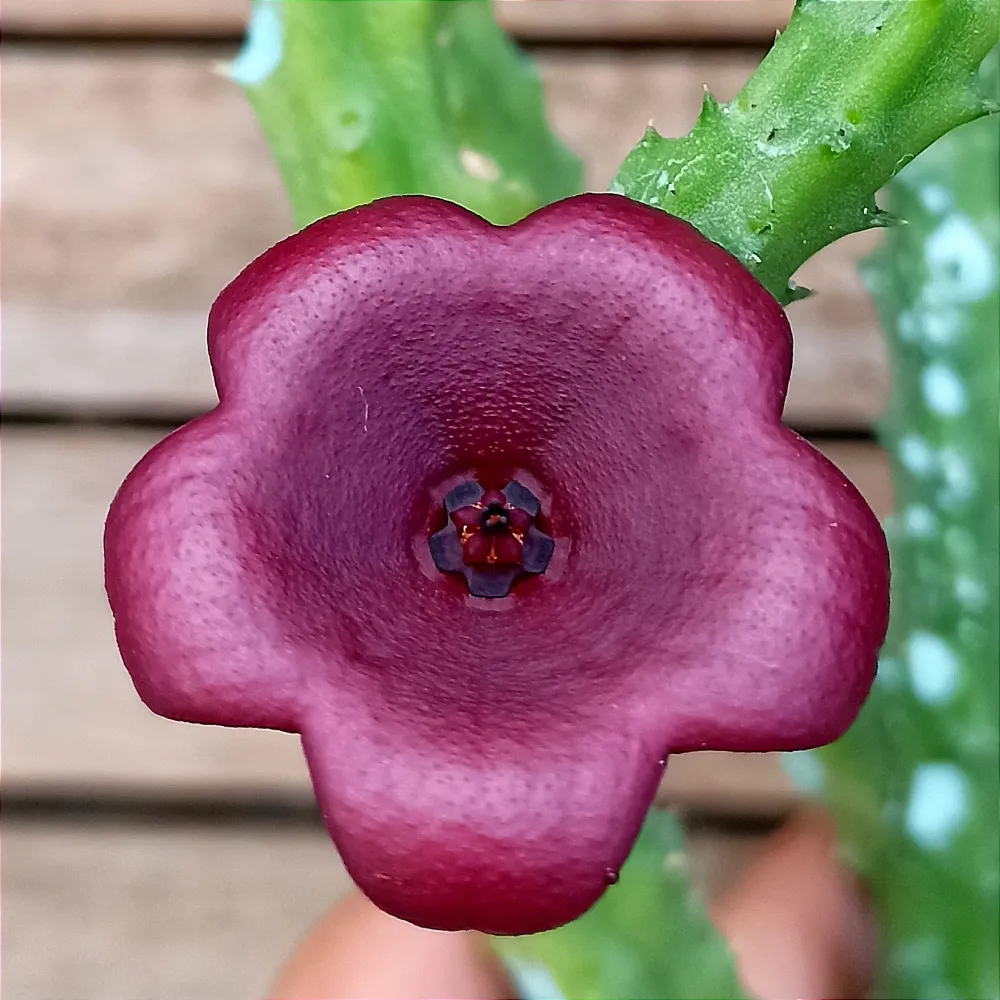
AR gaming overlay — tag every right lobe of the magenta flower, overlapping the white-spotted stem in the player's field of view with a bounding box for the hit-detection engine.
[647,430,888,753]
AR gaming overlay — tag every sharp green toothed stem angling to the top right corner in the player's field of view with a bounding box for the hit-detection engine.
[612,0,998,304]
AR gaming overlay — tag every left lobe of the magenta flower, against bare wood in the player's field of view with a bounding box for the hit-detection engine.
[104,412,302,731]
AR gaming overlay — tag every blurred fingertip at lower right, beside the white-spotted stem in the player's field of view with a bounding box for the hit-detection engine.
[712,810,876,1000]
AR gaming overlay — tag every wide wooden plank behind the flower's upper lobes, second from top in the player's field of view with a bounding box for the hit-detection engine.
[3,45,886,427]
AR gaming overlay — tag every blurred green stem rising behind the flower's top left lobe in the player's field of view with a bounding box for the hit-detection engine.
[230,0,582,226]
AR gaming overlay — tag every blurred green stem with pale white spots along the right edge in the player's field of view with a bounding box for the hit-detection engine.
[809,54,1000,1000]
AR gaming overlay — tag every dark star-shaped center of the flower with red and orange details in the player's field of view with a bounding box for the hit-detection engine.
[430,479,555,598]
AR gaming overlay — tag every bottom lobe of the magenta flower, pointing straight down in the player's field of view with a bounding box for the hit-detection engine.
[303,692,663,934]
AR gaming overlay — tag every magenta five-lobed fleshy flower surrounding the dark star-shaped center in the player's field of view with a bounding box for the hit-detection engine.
[106,195,888,933]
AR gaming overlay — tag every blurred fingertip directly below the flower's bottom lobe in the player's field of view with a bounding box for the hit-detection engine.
[268,892,515,1000]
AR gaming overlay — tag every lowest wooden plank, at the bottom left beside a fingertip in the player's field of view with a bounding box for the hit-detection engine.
[3,819,763,1000]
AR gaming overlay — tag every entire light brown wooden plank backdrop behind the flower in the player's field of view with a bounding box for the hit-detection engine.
[2,0,892,1000]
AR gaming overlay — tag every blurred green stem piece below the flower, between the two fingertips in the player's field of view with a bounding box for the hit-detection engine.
[494,810,745,1000]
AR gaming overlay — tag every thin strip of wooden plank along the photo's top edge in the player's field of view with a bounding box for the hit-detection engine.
[3,0,793,43]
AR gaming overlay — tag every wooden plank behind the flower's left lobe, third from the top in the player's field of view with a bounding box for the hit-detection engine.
[3,426,891,814]
